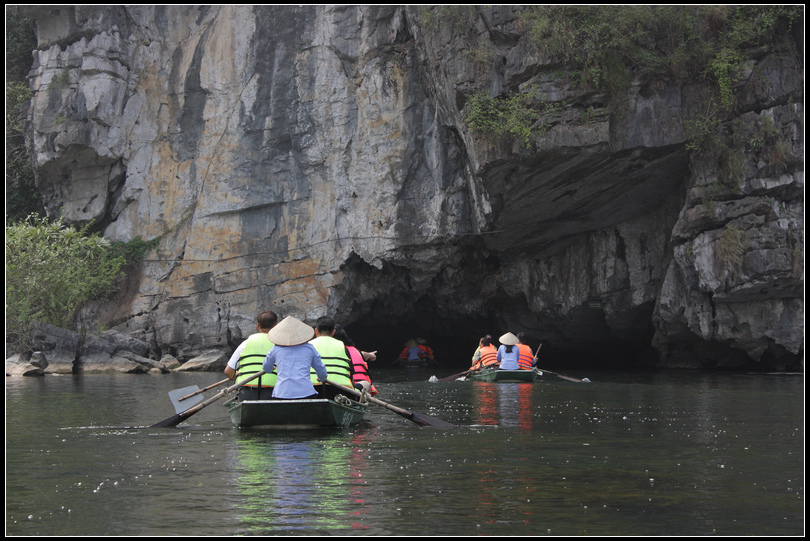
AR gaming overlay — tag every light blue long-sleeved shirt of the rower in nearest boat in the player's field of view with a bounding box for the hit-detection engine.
[262,343,327,398]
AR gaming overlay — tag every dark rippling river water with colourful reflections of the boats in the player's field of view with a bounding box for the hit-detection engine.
[6,366,804,536]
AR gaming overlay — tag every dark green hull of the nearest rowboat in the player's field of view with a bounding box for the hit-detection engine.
[226,396,366,428]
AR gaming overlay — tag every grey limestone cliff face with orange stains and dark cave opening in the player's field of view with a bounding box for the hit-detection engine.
[21,6,804,368]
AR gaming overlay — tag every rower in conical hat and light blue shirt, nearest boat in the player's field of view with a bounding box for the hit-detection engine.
[262,316,328,400]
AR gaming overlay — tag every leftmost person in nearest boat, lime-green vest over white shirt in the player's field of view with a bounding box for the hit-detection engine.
[225,310,278,400]
